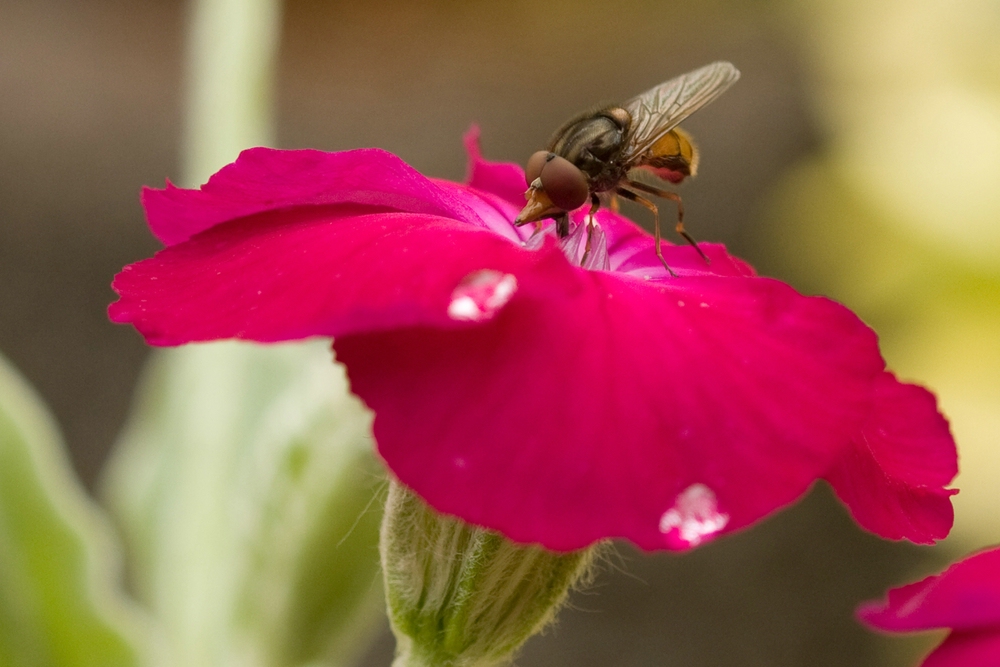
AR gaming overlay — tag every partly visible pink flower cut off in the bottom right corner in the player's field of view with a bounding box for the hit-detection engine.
[858,547,1000,667]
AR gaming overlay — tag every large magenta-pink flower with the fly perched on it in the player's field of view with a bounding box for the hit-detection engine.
[110,132,956,550]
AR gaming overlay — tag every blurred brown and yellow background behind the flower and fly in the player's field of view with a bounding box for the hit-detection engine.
[0,0,1000,667]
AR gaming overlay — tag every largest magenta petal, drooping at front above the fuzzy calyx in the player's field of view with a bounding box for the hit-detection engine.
[334,255,883,550]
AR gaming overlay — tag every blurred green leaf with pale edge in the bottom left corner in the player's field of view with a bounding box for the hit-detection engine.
[0,356,140,667]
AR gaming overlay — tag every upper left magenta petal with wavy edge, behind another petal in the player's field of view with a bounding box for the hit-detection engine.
[142,148,504,245]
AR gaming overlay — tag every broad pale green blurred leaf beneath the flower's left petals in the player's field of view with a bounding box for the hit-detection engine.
[105,341,385,667]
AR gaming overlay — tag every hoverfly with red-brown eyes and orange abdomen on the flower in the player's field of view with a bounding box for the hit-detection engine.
[514,61,740,275]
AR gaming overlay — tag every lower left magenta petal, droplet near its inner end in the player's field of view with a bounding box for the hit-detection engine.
[109,207,558,345]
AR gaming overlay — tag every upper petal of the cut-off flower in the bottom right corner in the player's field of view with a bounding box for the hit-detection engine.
[858,548,1000,636]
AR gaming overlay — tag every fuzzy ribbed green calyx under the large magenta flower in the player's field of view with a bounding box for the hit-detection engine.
[380,481,595,667]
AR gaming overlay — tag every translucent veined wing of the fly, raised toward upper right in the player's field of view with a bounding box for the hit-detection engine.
[622,61,740,164]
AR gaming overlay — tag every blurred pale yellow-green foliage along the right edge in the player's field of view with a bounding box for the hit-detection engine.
[758,0,1000,552]
